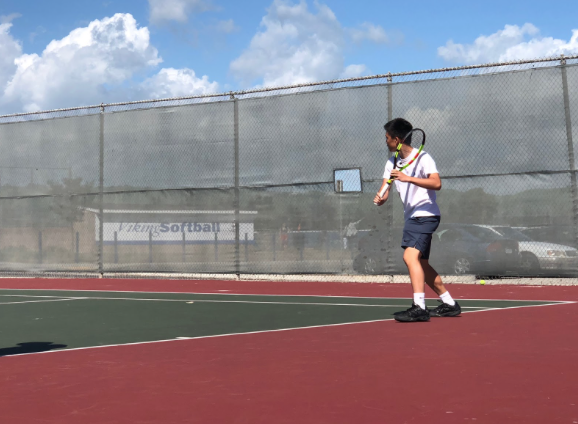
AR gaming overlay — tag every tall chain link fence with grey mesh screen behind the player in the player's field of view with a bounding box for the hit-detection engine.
[0,56,578,279]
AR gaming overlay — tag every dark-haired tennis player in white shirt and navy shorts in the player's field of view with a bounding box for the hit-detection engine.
[374,118,461,322]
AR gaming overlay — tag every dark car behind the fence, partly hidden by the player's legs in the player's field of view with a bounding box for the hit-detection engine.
[353,224,520,275]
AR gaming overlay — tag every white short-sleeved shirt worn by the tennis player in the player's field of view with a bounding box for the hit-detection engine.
[383,149,440,221]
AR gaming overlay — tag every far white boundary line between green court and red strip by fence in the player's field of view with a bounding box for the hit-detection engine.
[0,286,578,303]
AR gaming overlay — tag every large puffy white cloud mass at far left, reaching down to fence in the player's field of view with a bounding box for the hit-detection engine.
[0,14,219,113]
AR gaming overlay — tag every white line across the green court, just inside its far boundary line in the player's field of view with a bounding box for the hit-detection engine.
[0,294,512,309]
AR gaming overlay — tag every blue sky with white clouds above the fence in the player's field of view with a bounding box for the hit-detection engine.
[0,0,578,114]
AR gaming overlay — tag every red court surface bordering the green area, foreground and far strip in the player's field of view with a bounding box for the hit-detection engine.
[0,279,578,424]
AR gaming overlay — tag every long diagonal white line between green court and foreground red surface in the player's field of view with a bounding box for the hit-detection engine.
[3,298,576,358]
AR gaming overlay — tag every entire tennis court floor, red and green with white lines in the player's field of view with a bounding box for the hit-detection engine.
[0,279,578,423]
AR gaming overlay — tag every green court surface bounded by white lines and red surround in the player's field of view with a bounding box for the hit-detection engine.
[0,290,566,356]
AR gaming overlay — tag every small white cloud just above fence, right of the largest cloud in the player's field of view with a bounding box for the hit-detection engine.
[141,68,219,99]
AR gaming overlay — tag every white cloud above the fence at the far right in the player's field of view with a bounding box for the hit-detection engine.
[438,23,578,64]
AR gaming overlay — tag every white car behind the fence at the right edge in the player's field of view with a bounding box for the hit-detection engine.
[480,225,578,271]
